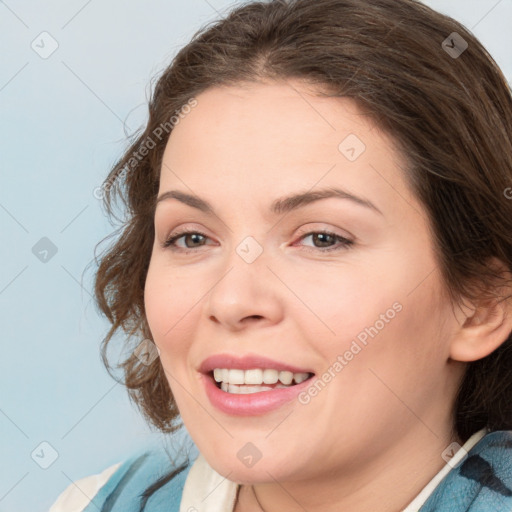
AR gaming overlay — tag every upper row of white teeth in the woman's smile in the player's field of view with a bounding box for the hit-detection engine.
[213,368,309,386]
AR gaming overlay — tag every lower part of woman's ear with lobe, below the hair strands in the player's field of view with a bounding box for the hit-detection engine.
[450,290,512,362]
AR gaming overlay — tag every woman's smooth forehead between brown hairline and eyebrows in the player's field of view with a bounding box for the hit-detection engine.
[160,82,420,218]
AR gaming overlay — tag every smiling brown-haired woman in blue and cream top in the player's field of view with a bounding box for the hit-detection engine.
[52,0,512,512]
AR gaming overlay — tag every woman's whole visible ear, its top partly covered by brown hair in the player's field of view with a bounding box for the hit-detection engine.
[450,259,512,361]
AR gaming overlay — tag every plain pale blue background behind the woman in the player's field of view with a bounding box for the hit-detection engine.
[0,0,512,512]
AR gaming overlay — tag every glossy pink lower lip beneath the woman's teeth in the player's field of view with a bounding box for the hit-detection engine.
[202,374,313,416]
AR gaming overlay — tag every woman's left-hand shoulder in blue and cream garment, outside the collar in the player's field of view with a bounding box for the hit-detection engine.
[49,448,196,512]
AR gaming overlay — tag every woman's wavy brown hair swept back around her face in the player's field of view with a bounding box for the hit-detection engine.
[95,0,512,440]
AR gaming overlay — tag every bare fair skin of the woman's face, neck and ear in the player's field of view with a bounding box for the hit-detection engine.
[145,81,512,512]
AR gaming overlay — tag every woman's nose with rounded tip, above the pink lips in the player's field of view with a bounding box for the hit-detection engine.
[204,243,284,331]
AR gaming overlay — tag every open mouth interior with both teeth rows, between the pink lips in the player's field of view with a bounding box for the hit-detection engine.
[208,368,314,395]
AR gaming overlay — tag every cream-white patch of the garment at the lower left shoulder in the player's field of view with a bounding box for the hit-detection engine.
[48,463,121,512]
